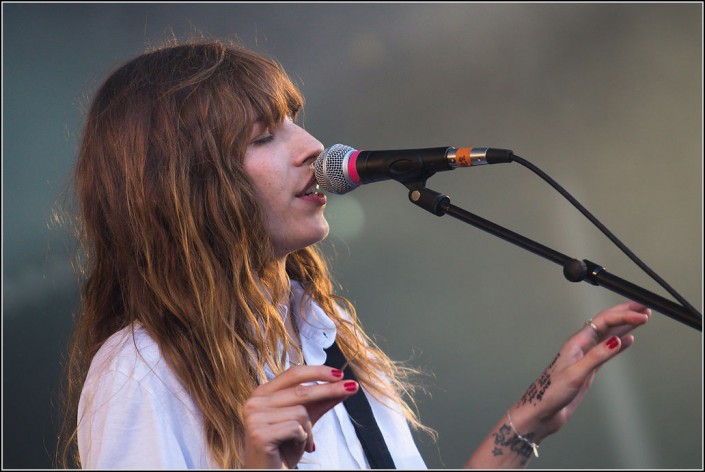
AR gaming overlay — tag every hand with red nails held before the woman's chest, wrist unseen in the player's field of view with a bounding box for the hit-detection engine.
[243,365,359,469]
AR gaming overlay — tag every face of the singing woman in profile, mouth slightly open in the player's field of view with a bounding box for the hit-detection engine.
[244,118,328,257]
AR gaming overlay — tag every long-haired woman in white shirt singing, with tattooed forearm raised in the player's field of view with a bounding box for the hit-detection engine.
[57,42,650,469]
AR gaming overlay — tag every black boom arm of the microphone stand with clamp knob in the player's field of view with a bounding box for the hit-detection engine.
[403,181,703,331]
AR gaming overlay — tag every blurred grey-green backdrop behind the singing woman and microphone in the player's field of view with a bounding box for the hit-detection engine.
[2,3,703,469]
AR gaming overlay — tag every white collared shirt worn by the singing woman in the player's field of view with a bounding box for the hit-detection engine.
[78,282,426,469]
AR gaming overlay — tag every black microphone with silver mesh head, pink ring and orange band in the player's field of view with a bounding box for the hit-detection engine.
[313,144,514,195]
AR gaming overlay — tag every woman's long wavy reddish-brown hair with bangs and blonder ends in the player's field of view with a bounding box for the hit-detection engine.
[58,41,426,468]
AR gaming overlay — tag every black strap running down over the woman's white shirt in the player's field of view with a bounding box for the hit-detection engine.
[325,342,396,469]
